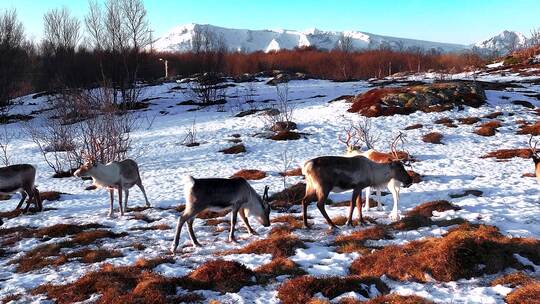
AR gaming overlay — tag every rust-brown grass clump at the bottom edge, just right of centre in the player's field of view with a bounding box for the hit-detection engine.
[278,275,389,304]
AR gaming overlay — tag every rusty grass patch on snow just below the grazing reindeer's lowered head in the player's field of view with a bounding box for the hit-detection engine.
[222,233,306,258]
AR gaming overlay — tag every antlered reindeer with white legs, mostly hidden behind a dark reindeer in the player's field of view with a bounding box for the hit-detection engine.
[339,119,410,219]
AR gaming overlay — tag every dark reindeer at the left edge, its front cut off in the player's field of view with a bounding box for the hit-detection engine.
[0,164,43,213]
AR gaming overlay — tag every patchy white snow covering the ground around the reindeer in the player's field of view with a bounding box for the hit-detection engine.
[0,70,540,303]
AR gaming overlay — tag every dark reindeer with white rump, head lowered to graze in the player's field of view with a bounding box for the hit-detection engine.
[171,176,270,253]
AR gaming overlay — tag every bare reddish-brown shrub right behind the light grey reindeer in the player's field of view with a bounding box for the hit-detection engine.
[25,85,135,173]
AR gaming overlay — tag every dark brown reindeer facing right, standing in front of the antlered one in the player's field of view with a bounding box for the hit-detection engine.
[302,155,412,228]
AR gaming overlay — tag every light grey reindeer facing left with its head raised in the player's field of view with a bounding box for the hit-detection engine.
[73,159,150,217]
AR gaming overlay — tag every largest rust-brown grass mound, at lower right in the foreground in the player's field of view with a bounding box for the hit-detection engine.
[351,224,540,282]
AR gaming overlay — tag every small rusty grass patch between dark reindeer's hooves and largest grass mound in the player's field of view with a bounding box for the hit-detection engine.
[334,225,392,254]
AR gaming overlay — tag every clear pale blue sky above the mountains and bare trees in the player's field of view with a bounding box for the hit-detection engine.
[0,0,540,44]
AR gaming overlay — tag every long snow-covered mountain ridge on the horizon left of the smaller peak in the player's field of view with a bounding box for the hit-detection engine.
[154,24,468,52]
